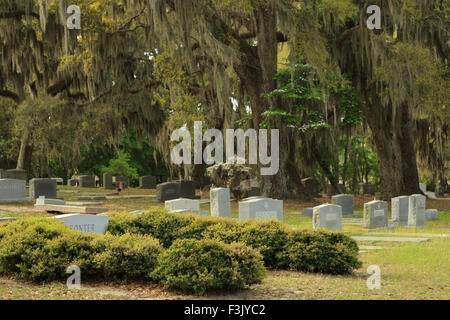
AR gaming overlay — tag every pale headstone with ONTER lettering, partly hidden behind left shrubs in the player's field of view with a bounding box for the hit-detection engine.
[55,214,109,234]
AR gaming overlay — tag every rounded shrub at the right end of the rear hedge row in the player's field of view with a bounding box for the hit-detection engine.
[281,230,362,275]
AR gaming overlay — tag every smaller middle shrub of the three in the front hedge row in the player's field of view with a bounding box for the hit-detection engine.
[94,233,163,281]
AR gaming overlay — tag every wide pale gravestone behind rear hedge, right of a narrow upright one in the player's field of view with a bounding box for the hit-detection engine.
[239,198,283,222]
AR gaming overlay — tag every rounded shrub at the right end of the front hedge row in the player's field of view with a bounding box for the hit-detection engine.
[152,239,265,295]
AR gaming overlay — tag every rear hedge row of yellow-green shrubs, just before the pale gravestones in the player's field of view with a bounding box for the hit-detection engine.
[108,209,362,274]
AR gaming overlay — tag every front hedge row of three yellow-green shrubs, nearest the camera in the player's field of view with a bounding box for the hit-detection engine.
[0,219,265,294]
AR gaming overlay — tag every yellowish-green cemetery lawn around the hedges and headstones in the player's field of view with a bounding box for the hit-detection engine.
[0,186,450,300]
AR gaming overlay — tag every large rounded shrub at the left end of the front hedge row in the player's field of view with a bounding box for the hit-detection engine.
[0,219,97,282]
